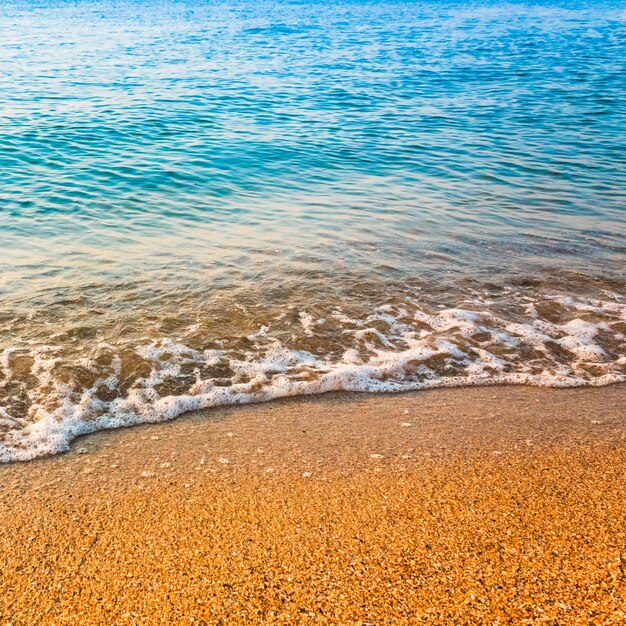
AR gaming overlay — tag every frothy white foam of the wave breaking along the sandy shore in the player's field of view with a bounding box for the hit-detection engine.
[0,297,626,462]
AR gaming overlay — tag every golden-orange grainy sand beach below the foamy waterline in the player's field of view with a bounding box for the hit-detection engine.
[0,385,626,626]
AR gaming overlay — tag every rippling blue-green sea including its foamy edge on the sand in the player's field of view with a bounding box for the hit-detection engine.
[0,0,626,462]
